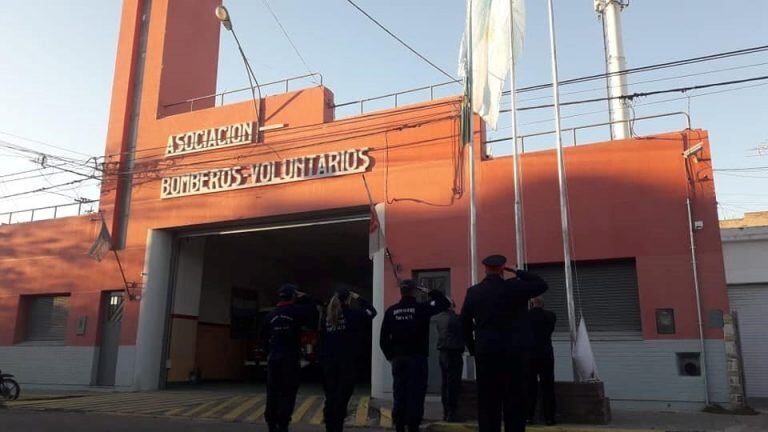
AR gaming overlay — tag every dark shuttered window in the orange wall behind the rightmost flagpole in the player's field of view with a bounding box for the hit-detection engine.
[528,259,641,332]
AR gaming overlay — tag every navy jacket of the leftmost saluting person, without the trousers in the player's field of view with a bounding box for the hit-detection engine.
[259,296,319,361]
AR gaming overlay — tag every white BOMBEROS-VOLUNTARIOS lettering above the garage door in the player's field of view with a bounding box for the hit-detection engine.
[160,147,371,198]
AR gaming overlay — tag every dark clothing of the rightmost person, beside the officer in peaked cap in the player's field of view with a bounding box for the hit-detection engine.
[528,307,557,424]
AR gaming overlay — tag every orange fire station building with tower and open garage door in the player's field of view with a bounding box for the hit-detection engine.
[0,0,729,408]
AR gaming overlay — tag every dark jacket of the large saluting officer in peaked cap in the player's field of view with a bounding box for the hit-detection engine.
[461,271,548,355]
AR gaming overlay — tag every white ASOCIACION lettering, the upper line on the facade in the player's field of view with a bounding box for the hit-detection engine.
[165,122,253,157]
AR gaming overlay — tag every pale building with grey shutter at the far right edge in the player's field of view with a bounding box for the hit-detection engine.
[720,211,768,398]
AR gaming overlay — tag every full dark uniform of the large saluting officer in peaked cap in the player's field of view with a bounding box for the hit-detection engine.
[461,271,547,432]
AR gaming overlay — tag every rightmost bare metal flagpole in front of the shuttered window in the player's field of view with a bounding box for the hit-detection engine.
[547,0,578,381]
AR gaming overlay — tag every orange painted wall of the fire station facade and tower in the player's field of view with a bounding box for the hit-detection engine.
[0,0,728,352]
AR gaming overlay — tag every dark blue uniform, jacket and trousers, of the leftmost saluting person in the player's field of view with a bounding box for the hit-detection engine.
[260,296,319,432]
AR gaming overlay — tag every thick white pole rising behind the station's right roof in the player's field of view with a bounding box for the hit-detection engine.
[595,0,630,140]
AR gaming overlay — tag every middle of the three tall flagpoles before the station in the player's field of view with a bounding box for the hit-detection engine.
[509,0,525,269]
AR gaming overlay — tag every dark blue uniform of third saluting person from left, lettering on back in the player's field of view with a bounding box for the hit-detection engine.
[379,291,451,432]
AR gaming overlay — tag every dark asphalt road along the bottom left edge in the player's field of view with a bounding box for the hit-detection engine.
[0,409,356,432]
